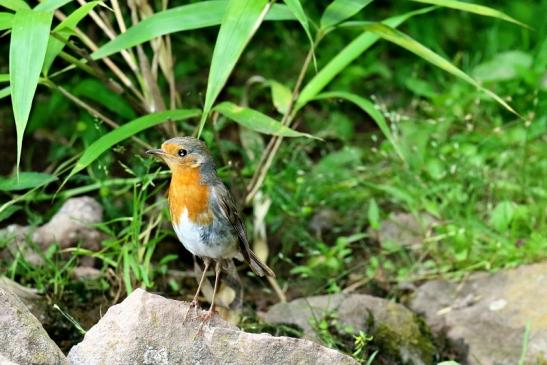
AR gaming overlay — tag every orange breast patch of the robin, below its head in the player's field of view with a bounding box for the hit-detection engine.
[168,166,213,225]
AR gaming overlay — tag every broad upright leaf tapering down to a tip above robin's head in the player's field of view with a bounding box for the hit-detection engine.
[198,0,270,137]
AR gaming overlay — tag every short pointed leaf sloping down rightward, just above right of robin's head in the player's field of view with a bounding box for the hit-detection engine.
[213,101,316,138]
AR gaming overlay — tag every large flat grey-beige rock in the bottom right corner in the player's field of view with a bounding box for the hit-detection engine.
[411,263,547,365]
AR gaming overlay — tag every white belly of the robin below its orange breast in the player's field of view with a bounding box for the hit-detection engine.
[173,209,238,259]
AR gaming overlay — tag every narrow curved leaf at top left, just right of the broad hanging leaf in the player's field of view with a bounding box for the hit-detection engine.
[42,1,100,75]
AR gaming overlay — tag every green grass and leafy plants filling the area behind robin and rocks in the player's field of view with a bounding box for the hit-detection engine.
[0,0,547,362]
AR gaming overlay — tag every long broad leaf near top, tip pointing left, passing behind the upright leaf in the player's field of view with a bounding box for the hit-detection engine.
[91,0,294,60]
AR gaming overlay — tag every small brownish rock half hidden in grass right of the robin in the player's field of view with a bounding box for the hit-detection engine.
[368,212,436,249]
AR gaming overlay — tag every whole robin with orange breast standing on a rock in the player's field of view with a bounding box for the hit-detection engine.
[146,137,275,328]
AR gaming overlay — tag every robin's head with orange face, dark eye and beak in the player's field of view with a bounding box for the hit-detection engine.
[146,137,214,171]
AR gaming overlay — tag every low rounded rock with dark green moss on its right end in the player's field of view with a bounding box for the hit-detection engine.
[264,294,436,365]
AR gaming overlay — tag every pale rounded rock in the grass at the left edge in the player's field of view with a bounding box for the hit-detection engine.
[0,196,103,266]
